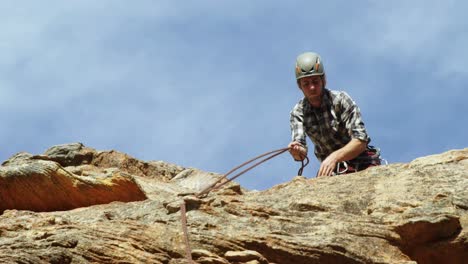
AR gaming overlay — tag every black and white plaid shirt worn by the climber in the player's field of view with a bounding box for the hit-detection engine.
[290,88,370,161]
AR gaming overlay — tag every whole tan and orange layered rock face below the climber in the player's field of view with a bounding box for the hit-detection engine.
[0,143,468,264]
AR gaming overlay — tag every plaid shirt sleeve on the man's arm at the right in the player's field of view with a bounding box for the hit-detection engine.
[341,92,370,142]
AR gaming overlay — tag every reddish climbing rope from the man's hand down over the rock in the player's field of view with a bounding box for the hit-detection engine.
[176,145,309,264]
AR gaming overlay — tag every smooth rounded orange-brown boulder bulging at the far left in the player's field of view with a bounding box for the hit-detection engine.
[0,150,147,212]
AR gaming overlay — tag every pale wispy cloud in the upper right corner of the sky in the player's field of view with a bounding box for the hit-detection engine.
[333,0,468,78]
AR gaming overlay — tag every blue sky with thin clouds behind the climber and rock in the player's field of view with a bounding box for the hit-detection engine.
[0,0,468,189]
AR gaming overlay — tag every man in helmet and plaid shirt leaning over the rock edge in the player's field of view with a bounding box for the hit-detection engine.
[288,52,380,177]
